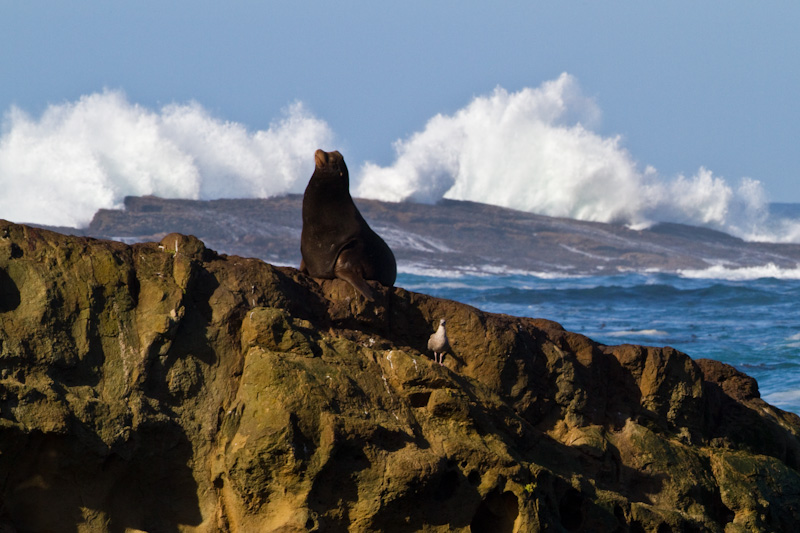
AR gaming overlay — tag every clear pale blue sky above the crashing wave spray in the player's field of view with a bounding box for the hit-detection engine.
[0,0,800,202]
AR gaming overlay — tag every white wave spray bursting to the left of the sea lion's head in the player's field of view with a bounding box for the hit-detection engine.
[0,91,333,226]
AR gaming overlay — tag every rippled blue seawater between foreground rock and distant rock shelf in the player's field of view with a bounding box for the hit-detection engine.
[397,267,800,413]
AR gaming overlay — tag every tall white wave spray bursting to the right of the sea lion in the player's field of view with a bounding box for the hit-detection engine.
[357,74,800,241]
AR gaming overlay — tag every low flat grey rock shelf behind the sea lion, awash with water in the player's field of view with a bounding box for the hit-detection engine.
[58,195,800,275]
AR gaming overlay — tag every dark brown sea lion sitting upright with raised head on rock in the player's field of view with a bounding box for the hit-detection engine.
[300,150,397,300]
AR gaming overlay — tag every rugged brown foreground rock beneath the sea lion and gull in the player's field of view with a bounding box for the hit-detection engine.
[0,218,800,532]
